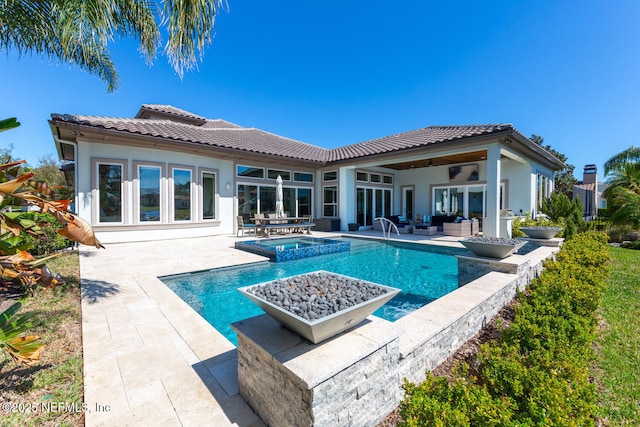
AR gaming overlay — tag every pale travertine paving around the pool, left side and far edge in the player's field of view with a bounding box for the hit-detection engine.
[80,232,524,426]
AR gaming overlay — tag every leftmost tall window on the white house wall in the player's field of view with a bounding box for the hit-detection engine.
[98,163,123,222]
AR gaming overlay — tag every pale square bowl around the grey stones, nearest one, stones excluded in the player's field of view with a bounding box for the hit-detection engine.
[238,271,400,344]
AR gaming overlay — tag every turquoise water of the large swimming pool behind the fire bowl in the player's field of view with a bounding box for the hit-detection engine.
[160,237,464,344]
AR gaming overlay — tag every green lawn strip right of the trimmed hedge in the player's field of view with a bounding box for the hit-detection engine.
[593,248,640,426]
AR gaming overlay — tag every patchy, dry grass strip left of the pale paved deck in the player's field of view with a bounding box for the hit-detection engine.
[0,251,84,426]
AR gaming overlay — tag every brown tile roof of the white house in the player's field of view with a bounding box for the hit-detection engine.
[51,104,534,164]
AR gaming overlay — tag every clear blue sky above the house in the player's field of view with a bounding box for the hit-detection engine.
[0,0,640,179]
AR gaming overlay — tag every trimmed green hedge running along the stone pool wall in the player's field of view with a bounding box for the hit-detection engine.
[400,233,611,426]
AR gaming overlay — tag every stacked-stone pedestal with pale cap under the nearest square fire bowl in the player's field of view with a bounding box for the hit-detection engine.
[233,314,401,426]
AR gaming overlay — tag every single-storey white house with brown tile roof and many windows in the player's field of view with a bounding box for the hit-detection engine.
[49,104,564,243]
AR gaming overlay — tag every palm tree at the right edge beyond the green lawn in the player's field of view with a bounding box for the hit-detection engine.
[604,147,640,229]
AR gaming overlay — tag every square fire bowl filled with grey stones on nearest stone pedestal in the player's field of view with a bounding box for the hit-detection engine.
[238,270,400,344]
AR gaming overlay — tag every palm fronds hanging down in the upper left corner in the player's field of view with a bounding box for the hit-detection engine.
[0,0,222,92]
